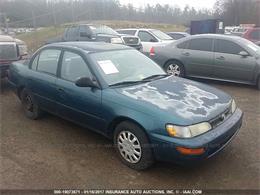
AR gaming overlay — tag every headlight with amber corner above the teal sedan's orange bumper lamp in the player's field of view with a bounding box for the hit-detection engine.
[166,122,212,138]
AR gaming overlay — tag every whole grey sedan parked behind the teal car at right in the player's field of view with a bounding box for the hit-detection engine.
[150,34,260,88]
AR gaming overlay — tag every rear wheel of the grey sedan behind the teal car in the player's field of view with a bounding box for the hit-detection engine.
[165,60,185,77]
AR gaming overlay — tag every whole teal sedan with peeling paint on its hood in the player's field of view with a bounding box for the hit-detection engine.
[9,42,242,170]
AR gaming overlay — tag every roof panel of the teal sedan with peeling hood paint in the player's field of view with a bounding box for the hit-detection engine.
[46,41,132,52]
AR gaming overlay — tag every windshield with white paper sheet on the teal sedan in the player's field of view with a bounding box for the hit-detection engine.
[90,50,166,85]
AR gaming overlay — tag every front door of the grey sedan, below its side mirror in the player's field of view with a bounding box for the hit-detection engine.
[214,39,256,82]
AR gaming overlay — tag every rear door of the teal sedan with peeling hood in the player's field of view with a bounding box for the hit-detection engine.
[28,49,61,113]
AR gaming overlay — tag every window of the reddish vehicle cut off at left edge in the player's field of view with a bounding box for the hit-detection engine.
[0,42,17,60]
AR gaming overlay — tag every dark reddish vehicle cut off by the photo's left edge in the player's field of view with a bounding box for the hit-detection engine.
[0,35,28,78]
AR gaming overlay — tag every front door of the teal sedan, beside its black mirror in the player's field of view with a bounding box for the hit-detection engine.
[57,51,103,129]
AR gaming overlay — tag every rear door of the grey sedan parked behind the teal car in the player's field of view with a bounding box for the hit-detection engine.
[181,38,214,77]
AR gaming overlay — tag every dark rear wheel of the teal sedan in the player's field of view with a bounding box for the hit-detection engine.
[21,89,42,120]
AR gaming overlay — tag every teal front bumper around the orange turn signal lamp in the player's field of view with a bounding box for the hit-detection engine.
[150,109,243,164]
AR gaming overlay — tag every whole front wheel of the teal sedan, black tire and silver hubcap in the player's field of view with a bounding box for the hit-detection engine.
[114,121,154,170]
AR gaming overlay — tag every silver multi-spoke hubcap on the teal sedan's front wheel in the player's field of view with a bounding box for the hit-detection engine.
[117,131,142,163]
